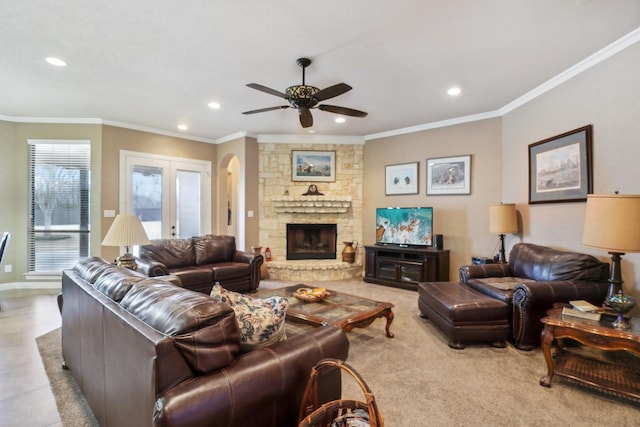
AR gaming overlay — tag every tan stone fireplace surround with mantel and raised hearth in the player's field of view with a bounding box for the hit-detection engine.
[255,142,364,283]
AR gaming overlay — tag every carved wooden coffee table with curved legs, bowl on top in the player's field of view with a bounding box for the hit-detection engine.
[255,284,394,338]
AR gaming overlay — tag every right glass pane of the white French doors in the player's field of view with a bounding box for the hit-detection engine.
[176,170,201,239]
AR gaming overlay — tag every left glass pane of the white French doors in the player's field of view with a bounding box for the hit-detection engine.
[131,165,162,239]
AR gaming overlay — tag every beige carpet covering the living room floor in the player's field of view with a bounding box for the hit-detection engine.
[37,281,640,427]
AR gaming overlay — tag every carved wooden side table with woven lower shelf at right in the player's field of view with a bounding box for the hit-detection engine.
[540,308,640,400]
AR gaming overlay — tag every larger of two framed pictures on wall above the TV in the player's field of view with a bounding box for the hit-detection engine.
[427,155,471,195]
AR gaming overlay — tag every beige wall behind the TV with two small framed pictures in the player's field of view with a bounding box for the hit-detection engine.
[363,119,504,280]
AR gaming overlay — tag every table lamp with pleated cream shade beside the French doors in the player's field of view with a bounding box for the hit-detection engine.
[102,215,149,270]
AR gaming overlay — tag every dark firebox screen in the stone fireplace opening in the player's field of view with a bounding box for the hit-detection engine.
[287,224,338,260]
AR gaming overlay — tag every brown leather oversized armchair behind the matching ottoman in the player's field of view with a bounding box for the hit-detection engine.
[460,243,609,350]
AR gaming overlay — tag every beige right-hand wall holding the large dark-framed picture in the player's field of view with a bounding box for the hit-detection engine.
[502,44,640,296]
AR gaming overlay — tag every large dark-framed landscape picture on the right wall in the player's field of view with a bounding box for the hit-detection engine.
[529,125,593,204]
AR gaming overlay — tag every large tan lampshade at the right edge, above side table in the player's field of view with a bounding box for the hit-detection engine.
[582,194,640,253]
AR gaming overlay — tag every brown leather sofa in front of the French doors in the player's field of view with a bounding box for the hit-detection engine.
[136,234,264,295]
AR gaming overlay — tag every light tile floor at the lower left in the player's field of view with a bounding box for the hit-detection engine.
[0,289,62,427]
